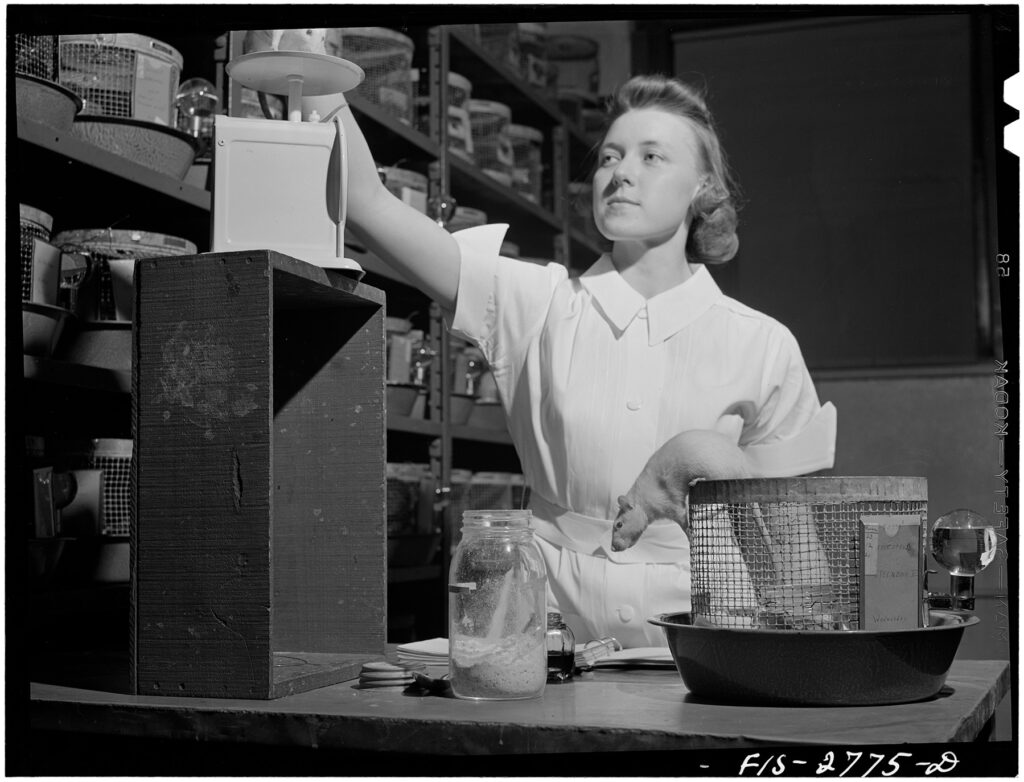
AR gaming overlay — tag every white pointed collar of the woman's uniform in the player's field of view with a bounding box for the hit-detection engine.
[580,253,723,345]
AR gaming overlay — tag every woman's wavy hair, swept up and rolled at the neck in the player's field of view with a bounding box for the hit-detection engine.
[608,76,739,263]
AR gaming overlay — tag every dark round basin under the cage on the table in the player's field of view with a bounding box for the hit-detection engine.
[649,611,978,706]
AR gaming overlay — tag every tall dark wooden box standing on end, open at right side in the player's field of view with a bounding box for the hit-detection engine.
[131,251,387,698]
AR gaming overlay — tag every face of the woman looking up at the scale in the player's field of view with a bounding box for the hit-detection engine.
[594,108,702,243]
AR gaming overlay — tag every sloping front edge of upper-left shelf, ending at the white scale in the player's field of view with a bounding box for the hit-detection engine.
[17,117,210,212]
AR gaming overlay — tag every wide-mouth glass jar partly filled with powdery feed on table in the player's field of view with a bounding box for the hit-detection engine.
[449,511,548,700]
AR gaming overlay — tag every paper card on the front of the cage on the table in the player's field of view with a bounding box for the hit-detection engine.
[860,514,922,631]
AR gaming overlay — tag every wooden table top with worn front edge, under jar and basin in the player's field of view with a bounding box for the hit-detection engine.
[31,660,1010,755]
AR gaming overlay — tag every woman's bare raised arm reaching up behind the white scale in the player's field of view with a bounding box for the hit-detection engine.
[339,105,461,310]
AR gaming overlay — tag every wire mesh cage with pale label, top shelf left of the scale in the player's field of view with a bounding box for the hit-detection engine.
[60,33,182,127]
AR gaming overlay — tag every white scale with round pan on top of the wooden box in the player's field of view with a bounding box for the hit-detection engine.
[212,51,365,278]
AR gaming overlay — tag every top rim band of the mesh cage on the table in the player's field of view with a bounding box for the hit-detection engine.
[690,475,928,505]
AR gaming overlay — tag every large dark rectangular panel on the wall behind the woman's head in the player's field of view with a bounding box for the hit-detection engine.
[674,13,994,368]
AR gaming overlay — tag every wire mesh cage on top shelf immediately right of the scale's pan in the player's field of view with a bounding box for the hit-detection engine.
[328,28,416,125]
